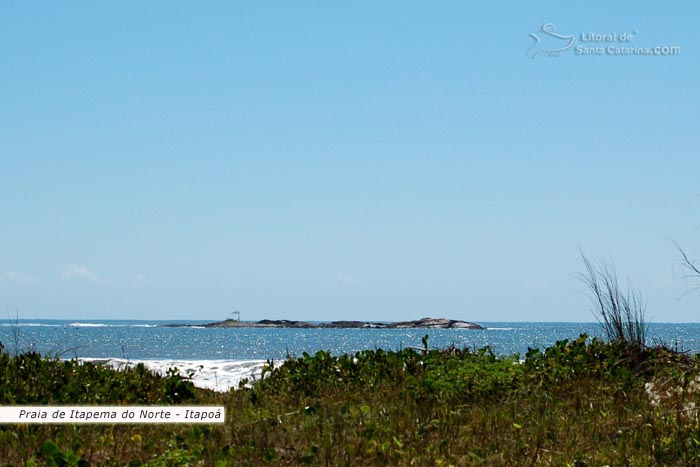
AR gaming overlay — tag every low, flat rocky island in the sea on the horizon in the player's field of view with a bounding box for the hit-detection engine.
[194,318,486,329]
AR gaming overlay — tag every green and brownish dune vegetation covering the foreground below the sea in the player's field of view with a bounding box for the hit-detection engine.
[0,335,700,467]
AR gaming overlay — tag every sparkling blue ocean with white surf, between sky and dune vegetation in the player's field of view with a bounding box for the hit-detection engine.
[0,319,700,391]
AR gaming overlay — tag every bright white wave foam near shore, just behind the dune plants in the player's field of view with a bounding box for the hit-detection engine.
[80,358,267,392]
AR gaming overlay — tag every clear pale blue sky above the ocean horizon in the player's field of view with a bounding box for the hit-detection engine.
[0,1,700,322]
